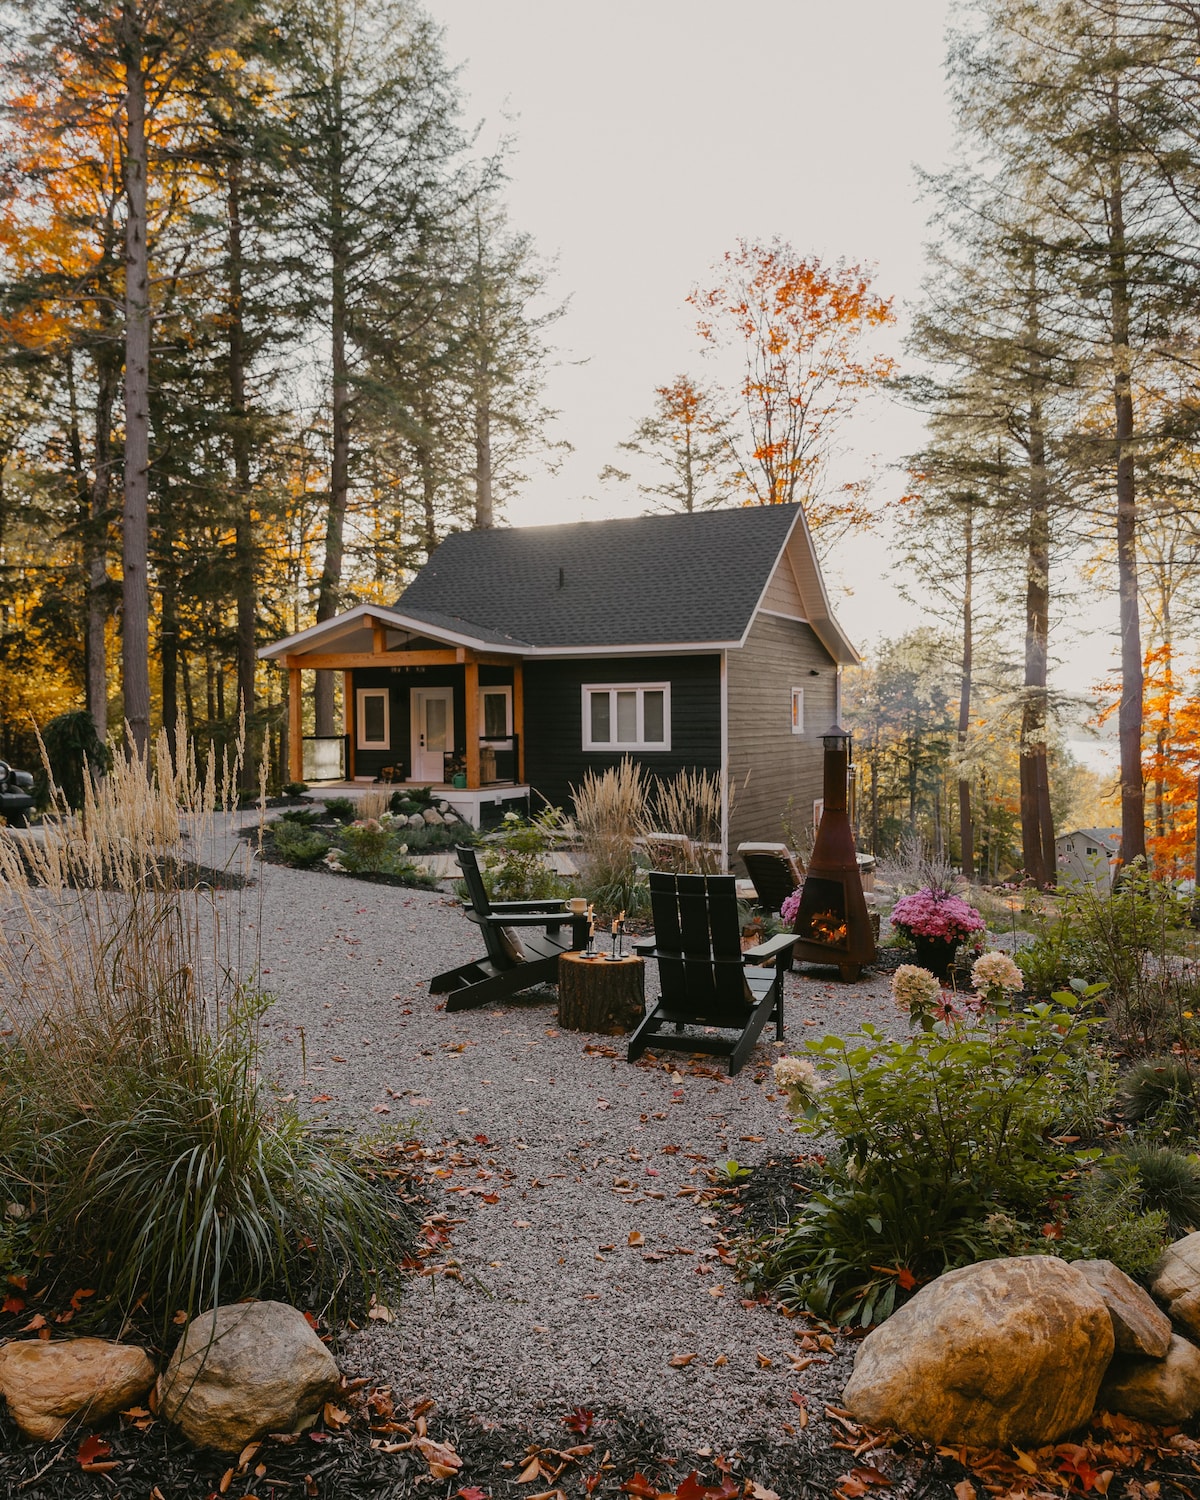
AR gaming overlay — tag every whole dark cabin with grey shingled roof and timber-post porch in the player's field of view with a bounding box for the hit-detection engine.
[260,506,858,851]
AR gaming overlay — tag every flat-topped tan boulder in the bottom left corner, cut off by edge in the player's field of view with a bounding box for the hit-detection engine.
[0,1338,155,1443]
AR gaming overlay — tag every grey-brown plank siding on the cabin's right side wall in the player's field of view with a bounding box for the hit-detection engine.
[728,614,837,858]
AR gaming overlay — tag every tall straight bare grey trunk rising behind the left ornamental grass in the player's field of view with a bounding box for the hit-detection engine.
[122,0,150,755]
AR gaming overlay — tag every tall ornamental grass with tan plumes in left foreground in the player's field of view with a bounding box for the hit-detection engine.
[0,735,402,1329]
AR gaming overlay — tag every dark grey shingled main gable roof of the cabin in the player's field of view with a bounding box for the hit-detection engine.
[393,506,858,662]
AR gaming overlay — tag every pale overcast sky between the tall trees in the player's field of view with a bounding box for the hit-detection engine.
[428,0,1116,762]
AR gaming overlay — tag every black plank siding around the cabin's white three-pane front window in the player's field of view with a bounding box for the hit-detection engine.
[525,654,722,807]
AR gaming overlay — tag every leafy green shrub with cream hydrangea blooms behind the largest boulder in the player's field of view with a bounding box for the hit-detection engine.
[756,992,1095,1325]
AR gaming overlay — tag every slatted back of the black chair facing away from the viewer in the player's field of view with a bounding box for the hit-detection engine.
[650,870,752,1026]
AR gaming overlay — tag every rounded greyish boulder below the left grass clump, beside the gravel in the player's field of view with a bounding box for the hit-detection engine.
[159,1302,338,1454]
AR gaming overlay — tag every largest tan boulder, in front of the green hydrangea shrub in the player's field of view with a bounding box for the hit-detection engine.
[843,1256,1113,1448]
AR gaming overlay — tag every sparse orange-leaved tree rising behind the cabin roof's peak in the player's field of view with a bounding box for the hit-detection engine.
[689,240,896,539]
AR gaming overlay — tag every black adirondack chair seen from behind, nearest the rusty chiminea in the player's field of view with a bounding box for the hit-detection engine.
[629,872,795,1074]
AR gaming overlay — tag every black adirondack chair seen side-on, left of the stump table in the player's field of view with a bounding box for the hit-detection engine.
[429,845,588,1011]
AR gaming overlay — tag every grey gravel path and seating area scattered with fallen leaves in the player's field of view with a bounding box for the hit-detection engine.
[211,822,896,1449]
